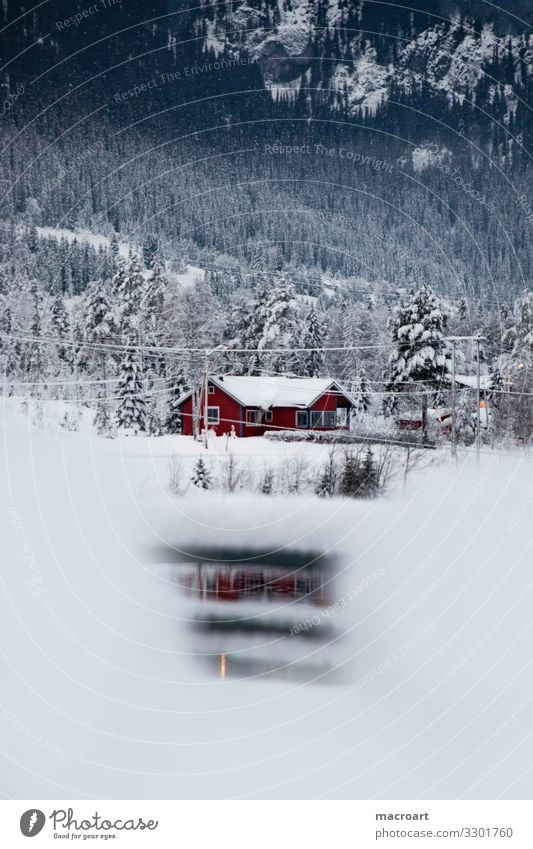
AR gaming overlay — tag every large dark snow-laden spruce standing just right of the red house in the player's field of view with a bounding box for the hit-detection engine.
[388,284,450,386]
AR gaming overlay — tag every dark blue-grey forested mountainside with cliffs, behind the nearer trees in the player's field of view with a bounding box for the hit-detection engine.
[0,0,533,300]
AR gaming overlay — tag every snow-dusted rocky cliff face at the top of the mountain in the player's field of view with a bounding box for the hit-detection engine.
[193,0,533,115]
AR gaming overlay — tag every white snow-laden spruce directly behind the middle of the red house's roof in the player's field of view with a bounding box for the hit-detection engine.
[257,274,301,373]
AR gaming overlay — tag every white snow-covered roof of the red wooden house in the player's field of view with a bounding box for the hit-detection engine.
[178,374,355,410]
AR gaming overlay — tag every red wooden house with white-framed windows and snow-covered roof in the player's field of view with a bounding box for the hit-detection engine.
[178,375,355,436]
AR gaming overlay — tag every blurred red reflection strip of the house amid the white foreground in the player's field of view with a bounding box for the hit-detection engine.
[180,563,329,605]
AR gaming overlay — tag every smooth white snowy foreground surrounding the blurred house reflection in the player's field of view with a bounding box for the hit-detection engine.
[0,400,533,799]
